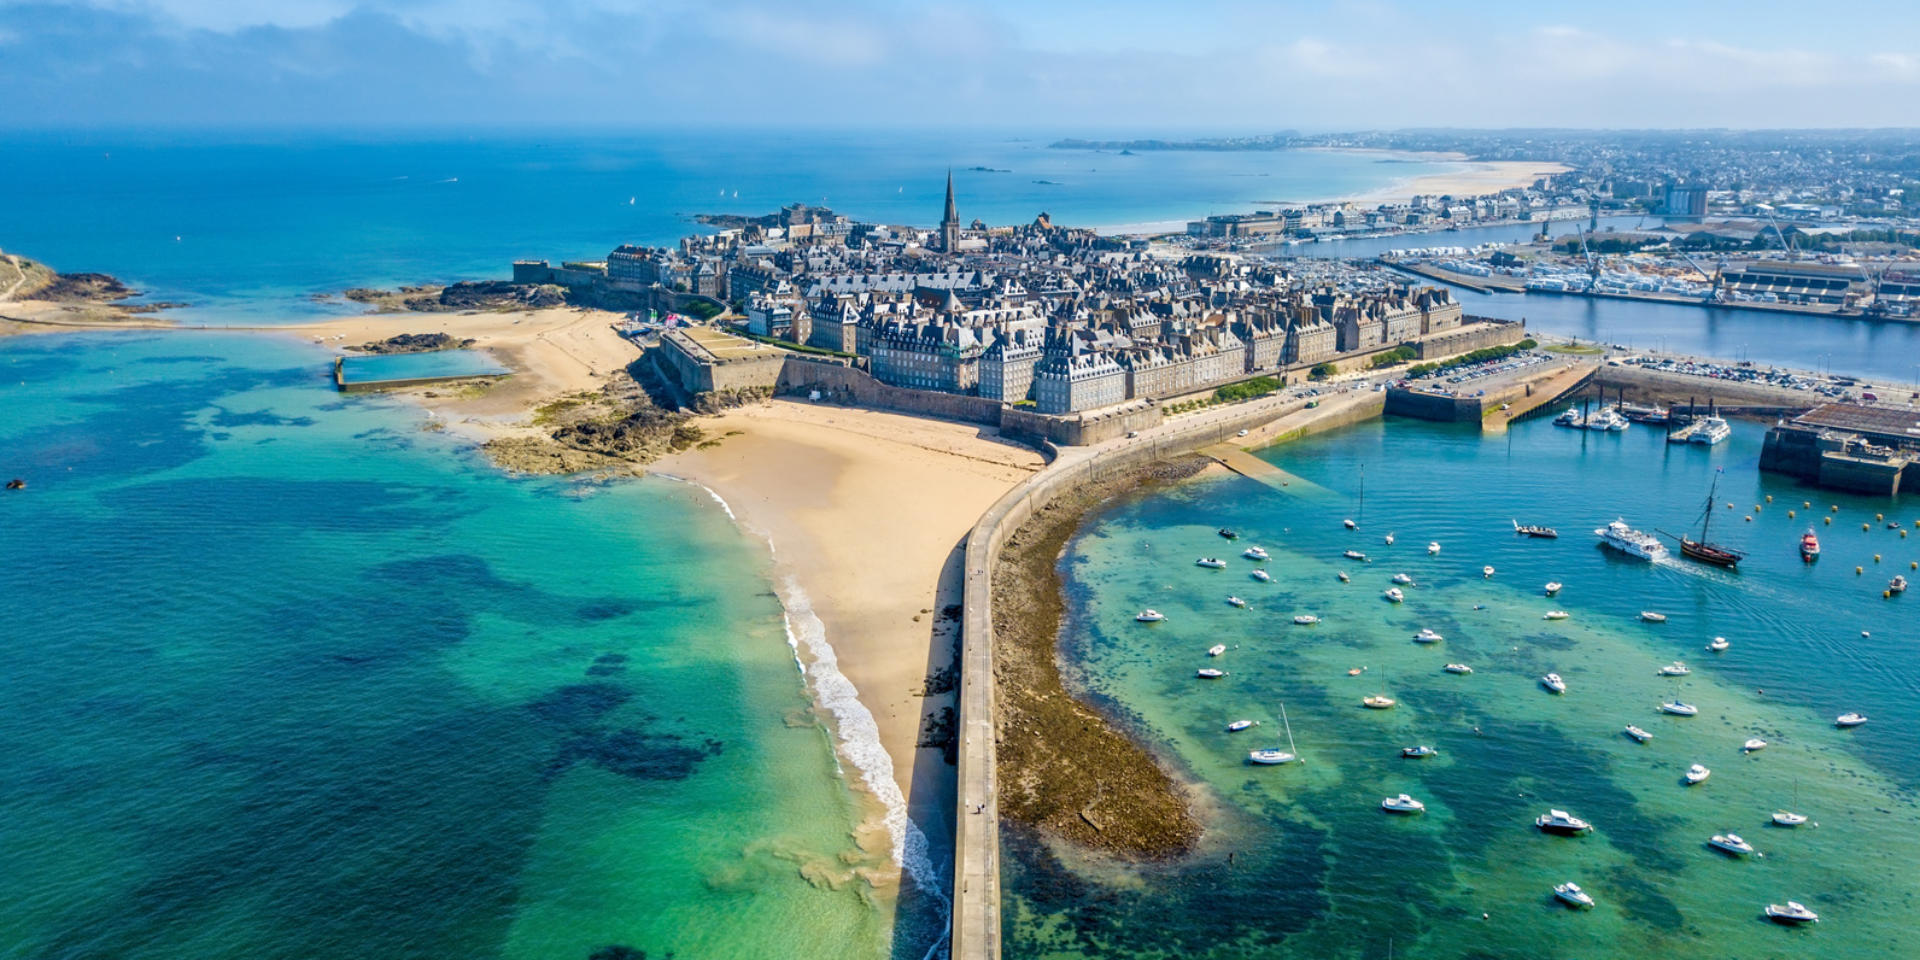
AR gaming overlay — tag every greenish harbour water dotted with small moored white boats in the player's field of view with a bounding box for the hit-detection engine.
[1006,420,1920,958]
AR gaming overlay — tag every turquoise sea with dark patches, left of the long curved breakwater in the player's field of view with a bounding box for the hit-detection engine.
[0,334,898,960]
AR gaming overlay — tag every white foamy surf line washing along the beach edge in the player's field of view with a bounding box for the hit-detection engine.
[672,474,952,960]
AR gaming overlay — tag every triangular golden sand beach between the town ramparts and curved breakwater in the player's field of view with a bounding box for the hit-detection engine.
[653,399,1041,883]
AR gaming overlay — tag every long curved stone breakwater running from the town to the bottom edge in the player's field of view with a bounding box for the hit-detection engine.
[950,385,1384,960]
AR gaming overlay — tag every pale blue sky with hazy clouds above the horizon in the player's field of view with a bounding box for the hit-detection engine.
[0,0,1920,129]
